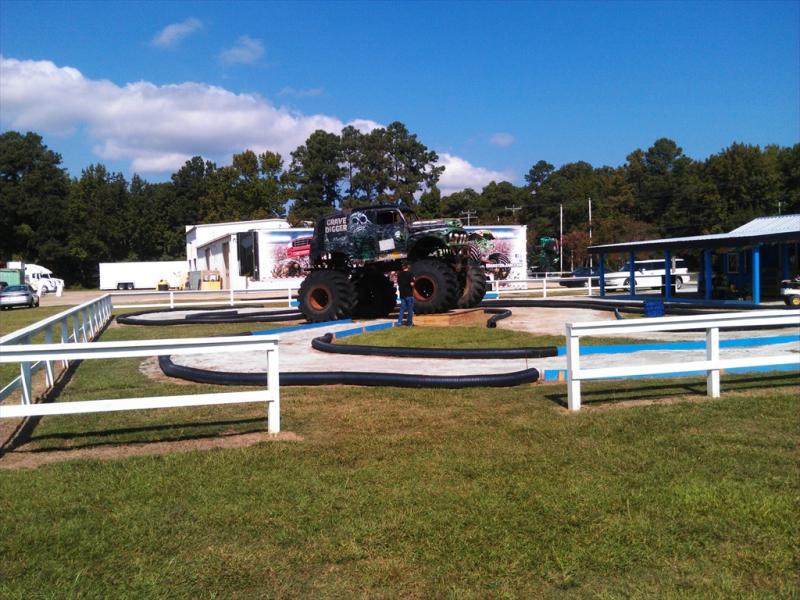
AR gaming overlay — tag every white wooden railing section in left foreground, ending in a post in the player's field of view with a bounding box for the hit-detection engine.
[0,336,281,433]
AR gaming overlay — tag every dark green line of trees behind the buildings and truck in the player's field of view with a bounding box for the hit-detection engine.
[0,122,800,286]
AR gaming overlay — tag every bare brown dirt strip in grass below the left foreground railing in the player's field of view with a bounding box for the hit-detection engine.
[0,431,303,469]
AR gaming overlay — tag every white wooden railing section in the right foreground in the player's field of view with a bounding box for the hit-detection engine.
[567,310,800,411]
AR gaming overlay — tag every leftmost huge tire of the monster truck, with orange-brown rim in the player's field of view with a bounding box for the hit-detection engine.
[297,269,356,323]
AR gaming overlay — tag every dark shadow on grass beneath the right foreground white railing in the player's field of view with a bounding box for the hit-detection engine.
[544,374,800,408]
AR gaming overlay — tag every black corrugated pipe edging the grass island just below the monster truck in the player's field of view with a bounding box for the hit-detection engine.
[311,333,558,360]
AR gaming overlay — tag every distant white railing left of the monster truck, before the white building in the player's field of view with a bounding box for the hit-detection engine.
[110,286,299,308]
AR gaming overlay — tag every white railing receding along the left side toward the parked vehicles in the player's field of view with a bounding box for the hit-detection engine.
[0,294,114,401]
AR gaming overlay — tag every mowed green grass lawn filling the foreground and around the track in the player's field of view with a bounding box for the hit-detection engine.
[0,312,800,599]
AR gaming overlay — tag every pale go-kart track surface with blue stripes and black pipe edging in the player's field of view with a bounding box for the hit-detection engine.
[123,303,800,387]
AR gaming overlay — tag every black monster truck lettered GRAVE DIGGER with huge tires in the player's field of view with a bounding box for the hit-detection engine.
[298,205,486,322]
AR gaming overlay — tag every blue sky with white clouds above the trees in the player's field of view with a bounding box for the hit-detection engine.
[0,0,800,191]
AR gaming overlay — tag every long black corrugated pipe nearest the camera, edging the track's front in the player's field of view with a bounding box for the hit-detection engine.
[158,356,539,389]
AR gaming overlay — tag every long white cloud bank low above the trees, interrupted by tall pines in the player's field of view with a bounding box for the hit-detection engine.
[0,57,513,194]
